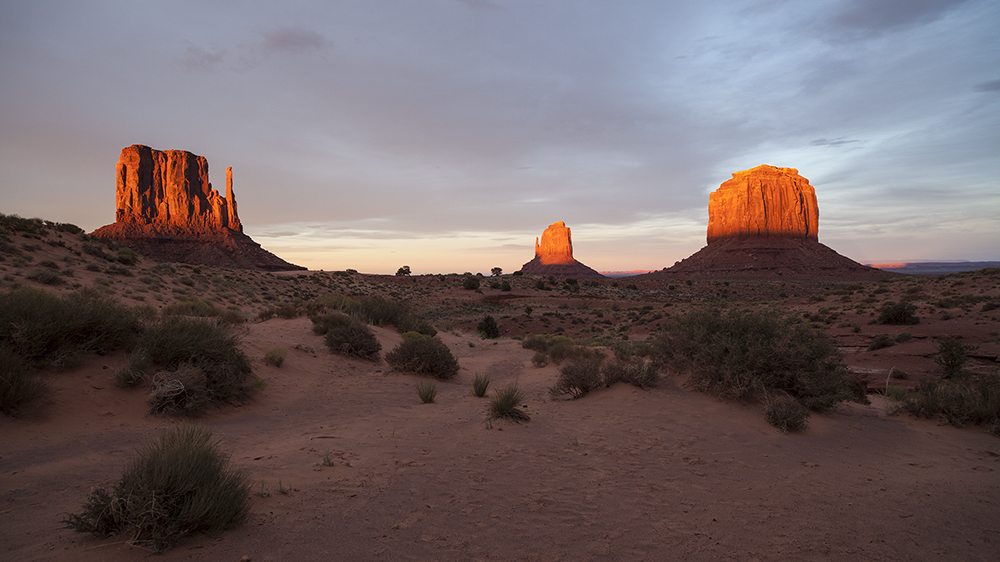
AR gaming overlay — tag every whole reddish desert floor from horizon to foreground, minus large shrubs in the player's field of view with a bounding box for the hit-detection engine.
[0,221,1000,562]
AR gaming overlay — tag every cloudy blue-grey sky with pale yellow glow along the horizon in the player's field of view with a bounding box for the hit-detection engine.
[0,0,1000,274]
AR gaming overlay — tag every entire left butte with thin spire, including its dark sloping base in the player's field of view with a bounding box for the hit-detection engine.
[91,144,305,271]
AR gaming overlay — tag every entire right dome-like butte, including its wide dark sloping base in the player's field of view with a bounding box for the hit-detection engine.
[644,166,896,280]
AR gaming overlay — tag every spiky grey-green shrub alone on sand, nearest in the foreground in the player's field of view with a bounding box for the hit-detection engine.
[63,426,251,552]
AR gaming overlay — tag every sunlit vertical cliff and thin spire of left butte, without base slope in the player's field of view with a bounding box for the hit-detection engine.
[115,144,243,232]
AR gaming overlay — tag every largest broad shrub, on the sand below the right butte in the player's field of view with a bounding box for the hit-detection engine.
[654,309,856,409]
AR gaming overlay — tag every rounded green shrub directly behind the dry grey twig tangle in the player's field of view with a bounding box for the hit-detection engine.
[135,316,253,401]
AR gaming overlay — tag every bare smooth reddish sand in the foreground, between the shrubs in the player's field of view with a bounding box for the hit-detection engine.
[0,318,1000,562]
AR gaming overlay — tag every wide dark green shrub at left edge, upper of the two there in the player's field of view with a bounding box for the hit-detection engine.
[0,288,142,365]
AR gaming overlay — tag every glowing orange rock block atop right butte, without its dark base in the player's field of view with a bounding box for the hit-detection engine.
[708,165,819,244]
